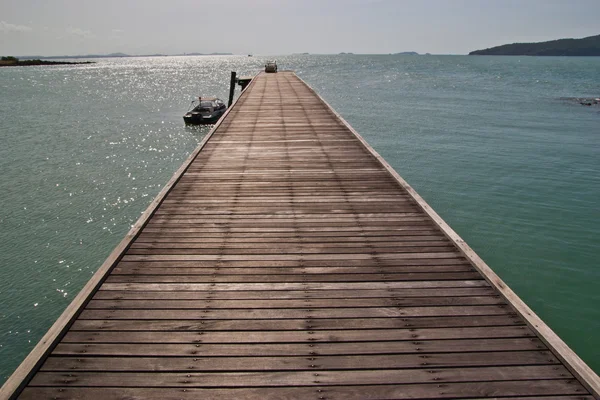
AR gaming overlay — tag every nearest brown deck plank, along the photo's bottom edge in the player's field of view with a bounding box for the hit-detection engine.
[17,379,592,400]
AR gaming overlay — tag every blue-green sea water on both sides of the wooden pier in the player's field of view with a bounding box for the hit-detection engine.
[0,55,600,383]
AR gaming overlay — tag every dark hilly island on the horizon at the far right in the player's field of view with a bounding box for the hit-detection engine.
[469,35,600,57]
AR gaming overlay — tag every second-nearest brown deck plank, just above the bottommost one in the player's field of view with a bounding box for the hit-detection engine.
[31,365,570,388]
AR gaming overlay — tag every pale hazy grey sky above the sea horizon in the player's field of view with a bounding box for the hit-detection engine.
[0,0,600,56]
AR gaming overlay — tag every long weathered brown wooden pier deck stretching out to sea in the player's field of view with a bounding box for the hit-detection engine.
[0,72,599,400]
